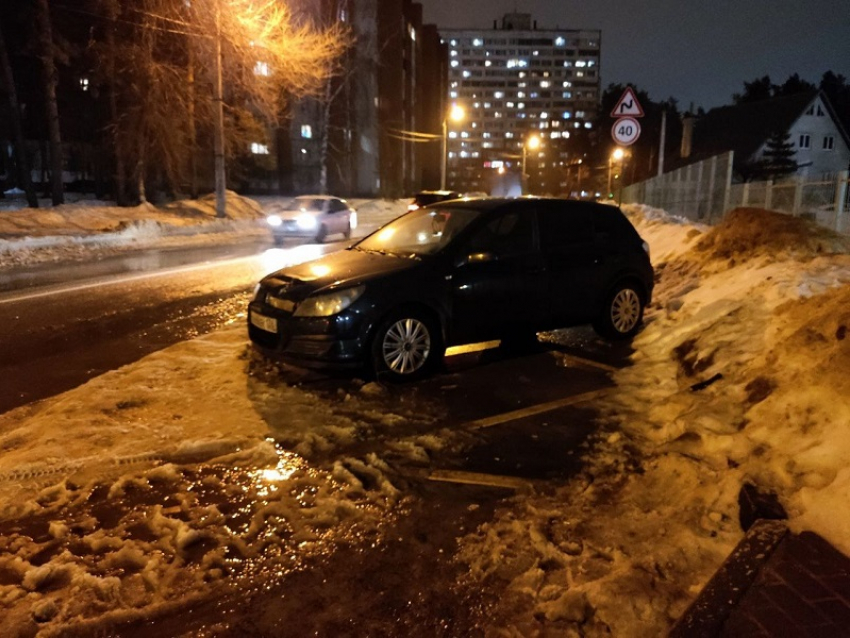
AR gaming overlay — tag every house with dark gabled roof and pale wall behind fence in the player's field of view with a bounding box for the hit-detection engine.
[682,91,850,180]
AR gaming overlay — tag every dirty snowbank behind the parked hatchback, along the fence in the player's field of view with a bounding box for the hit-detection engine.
[458,209,850,637]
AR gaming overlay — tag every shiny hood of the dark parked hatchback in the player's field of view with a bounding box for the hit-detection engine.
[261,249,421,300]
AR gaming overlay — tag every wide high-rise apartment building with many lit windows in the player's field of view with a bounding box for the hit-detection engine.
[440,13,601,195]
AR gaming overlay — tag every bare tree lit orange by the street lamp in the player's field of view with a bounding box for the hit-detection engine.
[92,0,346,215]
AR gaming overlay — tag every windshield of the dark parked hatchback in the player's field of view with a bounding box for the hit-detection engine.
[354,208,481,257]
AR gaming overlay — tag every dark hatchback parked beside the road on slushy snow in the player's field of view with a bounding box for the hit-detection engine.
[248,199,653,380]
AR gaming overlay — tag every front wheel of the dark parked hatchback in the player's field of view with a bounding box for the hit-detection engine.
[371,308,445,383]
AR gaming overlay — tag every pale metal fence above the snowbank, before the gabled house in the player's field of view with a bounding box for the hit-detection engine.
[622,152,850,234]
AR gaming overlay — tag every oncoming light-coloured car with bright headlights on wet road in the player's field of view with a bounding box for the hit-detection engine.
[266,195,357,245]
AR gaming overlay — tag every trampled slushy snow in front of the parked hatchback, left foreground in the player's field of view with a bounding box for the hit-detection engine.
[0,322,438,636]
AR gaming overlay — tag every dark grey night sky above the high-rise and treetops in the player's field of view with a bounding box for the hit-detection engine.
[419,0,850,110]
